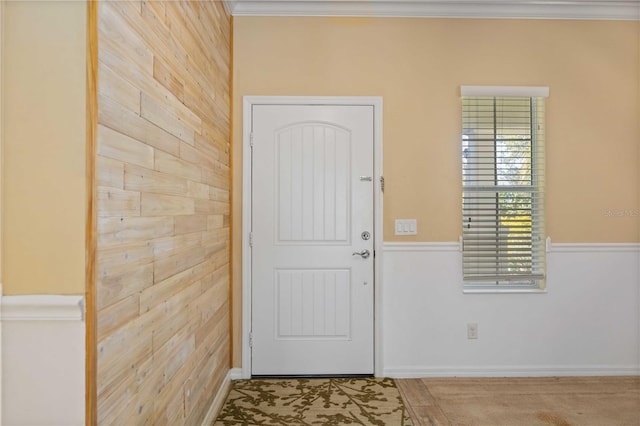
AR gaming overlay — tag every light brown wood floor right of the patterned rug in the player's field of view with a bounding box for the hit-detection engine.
[396,377,640,426]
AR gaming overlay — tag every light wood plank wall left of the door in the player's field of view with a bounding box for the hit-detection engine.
[96,1,231,425]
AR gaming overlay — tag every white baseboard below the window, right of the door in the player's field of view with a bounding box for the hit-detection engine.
[384,365,640,379]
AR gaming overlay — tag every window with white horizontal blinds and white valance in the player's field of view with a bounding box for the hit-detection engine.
[461,86,548,290]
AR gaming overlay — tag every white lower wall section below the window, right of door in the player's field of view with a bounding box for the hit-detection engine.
[383,243,640,377]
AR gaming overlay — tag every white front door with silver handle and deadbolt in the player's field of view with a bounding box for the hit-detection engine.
[251,105,374,375]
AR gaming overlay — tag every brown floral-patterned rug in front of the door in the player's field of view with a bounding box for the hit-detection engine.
[213,378,413,426]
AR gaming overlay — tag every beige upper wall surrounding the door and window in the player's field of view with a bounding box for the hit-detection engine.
[233,17,640,365]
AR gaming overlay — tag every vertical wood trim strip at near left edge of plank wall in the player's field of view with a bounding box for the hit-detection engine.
[85,0,98,426]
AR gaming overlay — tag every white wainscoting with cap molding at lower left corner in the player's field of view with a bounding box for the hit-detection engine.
[0,293,85,426]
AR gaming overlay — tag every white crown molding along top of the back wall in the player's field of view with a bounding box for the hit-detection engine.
[225,0,640,21]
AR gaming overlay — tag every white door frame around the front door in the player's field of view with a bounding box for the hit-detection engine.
[241,96,383,379]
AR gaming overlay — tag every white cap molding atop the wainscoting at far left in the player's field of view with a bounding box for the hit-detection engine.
[0,295,84,321]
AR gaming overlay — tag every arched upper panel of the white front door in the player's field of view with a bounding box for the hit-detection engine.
[275,123,351,243]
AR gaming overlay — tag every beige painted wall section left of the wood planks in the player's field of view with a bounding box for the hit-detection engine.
[2,1,86,294]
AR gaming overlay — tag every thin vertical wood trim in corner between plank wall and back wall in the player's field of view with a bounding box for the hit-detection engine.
[225,15,235,368]
